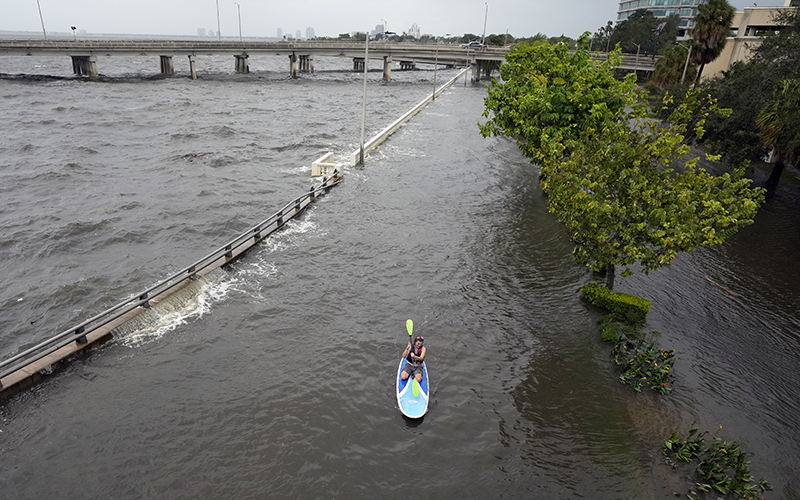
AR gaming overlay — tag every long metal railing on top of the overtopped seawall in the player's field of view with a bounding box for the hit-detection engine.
[0,172,343,389]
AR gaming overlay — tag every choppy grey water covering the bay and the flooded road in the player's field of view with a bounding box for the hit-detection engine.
[0,50,800,499]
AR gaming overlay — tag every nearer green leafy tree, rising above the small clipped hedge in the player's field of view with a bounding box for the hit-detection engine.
[542,90,763,288]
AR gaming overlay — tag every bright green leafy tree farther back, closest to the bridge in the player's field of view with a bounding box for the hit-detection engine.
[479,35,636,165]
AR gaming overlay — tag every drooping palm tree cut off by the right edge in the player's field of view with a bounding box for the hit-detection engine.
[756,78,800,187]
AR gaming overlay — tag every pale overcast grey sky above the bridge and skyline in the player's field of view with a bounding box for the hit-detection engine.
[0,0,783,37]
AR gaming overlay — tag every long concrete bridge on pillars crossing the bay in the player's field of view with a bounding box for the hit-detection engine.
[0,40,655,81]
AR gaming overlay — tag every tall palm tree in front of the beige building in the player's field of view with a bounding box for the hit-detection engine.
[692,0,736,82]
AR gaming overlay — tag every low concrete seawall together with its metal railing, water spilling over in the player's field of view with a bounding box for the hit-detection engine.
[0,172,344,391]
